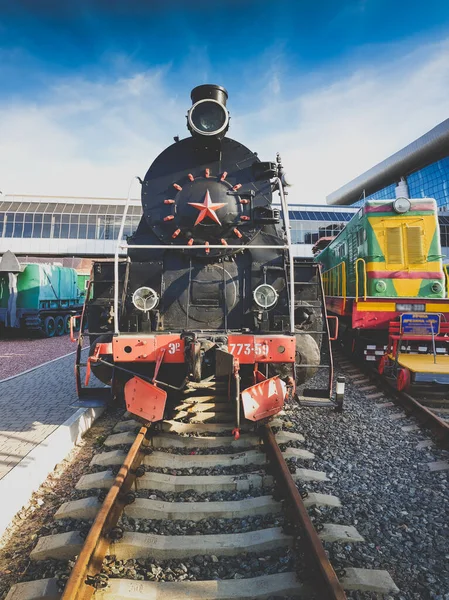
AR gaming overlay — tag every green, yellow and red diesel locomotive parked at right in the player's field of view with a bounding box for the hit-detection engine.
[315,198,449,361]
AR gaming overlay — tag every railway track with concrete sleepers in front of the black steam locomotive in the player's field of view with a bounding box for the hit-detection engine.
[7,382,397,600]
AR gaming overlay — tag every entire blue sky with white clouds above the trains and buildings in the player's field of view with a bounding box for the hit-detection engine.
[0,0,449,203]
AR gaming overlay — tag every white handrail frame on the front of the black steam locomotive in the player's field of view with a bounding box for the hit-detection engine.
[114,177,295,334]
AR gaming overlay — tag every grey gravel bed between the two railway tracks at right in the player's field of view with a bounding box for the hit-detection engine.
[286,352,449,600]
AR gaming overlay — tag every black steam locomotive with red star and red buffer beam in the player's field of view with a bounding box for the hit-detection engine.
[76,85,322,435]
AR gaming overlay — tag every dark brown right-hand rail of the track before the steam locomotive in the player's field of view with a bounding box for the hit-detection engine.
[259,425,346,600]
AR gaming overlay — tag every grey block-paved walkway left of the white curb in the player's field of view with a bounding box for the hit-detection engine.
[0,346,94,479]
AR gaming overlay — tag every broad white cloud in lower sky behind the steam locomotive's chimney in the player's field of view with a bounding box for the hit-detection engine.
[0,43,449,203]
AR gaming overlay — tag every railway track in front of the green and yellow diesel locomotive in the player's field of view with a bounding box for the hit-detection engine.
[336,352,449,448]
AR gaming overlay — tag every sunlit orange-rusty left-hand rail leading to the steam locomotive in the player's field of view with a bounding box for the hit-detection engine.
[61,427,149,600]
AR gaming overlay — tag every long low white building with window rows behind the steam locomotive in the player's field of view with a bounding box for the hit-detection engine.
[0,195,357,258]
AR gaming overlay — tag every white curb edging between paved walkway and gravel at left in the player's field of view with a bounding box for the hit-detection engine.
[0,407,104,537]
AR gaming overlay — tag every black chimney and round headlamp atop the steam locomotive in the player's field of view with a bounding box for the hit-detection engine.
[187,84,229,139]
